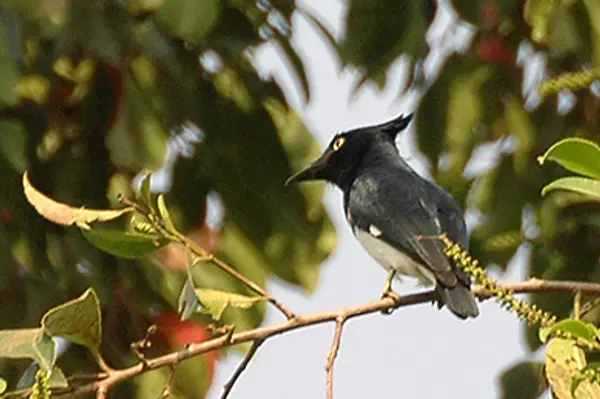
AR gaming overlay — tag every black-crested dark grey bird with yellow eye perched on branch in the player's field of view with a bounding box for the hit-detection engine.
[285,113,479,319]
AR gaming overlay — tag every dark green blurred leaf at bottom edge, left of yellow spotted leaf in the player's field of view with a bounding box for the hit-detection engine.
[500,361,547,399]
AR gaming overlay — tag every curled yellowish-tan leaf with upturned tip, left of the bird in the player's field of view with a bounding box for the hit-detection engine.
[23,172,133,229]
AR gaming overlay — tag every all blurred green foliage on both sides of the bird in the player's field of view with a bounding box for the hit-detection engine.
[0,0,600,397]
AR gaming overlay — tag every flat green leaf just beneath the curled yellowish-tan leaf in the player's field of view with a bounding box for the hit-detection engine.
[81,228,168,259]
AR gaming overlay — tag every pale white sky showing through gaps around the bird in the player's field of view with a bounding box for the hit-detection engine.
[208,0,540,399]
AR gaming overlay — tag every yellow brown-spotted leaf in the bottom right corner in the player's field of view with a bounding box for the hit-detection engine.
[545,338,600,399]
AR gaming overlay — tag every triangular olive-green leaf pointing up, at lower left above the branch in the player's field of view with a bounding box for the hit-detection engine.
[42,288,102,349]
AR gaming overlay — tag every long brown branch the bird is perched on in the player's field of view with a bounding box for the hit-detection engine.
[53,279,600,398]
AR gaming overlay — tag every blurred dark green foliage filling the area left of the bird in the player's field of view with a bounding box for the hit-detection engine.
[0,0,336,397]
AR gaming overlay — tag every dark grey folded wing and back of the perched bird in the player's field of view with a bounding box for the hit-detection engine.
[348,175,466,287]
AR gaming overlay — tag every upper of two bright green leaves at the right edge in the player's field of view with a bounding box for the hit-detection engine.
[538,137,600,180]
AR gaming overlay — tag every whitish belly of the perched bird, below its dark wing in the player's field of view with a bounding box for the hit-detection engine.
[354,228,436,285]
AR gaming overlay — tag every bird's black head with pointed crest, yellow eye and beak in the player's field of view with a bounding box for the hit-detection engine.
[285,114,412,189]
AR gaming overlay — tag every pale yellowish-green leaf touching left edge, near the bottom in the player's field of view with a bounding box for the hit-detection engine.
[0,328,56,370]
